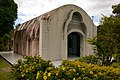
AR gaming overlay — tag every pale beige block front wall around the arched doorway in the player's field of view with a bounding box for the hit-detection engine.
[42,5,96,60]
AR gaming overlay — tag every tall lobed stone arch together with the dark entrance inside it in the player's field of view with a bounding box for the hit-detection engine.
[64,10,87,59]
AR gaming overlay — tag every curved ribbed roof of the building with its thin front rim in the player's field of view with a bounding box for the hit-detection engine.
[16,4,92,38]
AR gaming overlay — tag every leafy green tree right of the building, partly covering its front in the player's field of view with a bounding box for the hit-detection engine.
[88,4,120,65]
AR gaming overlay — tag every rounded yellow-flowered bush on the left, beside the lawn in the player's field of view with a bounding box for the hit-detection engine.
[11,56,54,80]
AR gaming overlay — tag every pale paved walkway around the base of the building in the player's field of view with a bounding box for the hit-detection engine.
[0,51,79,67]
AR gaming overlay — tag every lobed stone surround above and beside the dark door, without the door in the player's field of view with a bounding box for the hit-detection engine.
[65,11,86,57]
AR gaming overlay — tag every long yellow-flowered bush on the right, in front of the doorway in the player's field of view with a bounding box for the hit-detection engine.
[43,60,120,80]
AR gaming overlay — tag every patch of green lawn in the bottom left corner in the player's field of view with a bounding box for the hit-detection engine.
[0,56,12,80]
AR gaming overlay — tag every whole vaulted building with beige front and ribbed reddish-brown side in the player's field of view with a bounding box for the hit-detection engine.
[14,4,97,60]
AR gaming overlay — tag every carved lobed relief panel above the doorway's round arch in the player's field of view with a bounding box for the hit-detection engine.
[63,10,86,39]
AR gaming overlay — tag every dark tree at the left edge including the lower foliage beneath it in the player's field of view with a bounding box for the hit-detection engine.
[0,0,17,51]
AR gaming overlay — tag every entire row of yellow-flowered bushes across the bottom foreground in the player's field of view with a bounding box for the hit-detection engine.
[12,56,120,80]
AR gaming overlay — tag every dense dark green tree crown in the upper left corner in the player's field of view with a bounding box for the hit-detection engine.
[0,0,17,37]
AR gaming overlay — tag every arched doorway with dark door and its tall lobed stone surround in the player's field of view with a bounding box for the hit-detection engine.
[63,11,87,60]
